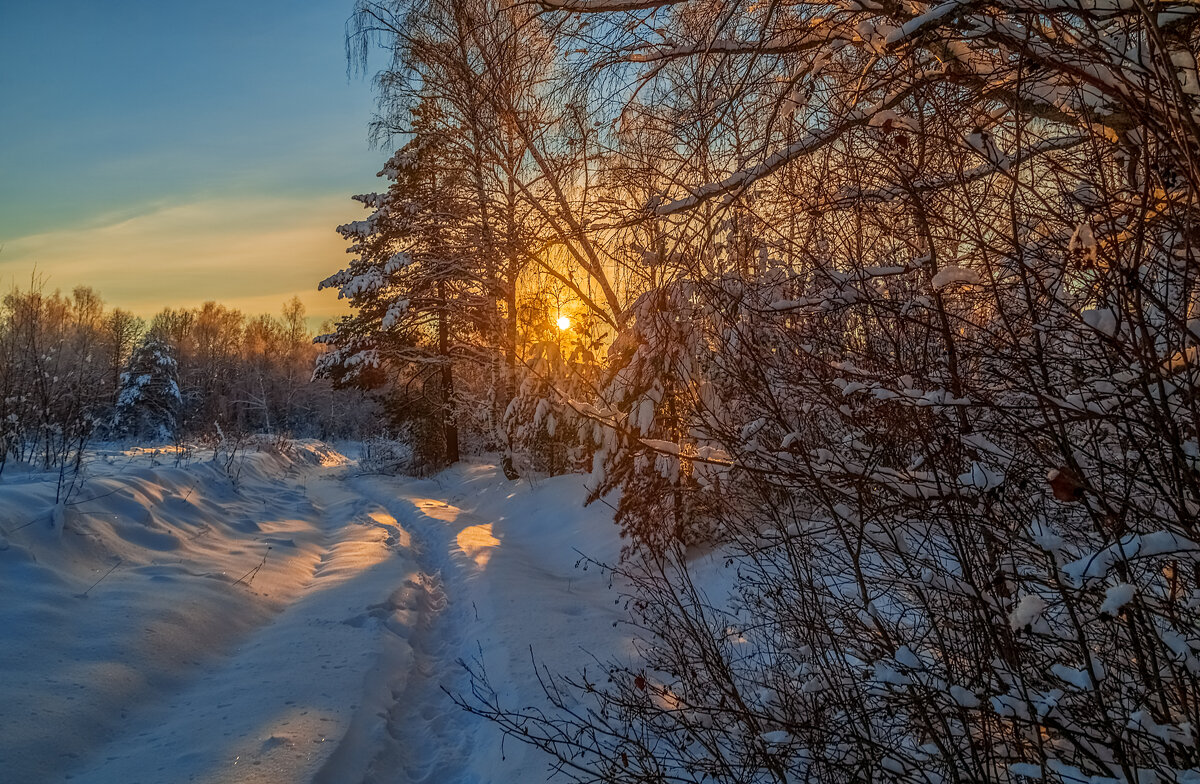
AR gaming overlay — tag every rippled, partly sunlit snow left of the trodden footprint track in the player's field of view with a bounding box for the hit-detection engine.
[0,443,415,783]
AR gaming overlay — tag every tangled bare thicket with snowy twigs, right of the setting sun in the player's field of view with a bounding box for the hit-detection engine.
[446,0,1200,782]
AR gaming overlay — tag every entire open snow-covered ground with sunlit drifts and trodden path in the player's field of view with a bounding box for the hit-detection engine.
[0,443,622,784]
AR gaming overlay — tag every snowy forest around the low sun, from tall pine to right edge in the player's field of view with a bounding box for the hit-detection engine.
[307,0,1200,783]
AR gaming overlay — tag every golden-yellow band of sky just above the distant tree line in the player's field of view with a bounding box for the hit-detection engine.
[0,194,355,323]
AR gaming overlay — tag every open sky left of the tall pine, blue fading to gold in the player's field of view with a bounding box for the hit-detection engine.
[0,0,388,321]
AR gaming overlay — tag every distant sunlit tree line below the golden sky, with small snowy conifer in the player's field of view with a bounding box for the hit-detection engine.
[0,280,373,471]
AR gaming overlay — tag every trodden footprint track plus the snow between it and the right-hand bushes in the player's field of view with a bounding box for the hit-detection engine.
[355,466,624,784]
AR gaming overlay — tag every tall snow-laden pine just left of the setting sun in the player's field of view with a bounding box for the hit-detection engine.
[318,100,491,467]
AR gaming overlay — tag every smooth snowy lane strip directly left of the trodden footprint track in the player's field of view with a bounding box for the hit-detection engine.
[64,470,415,784]
